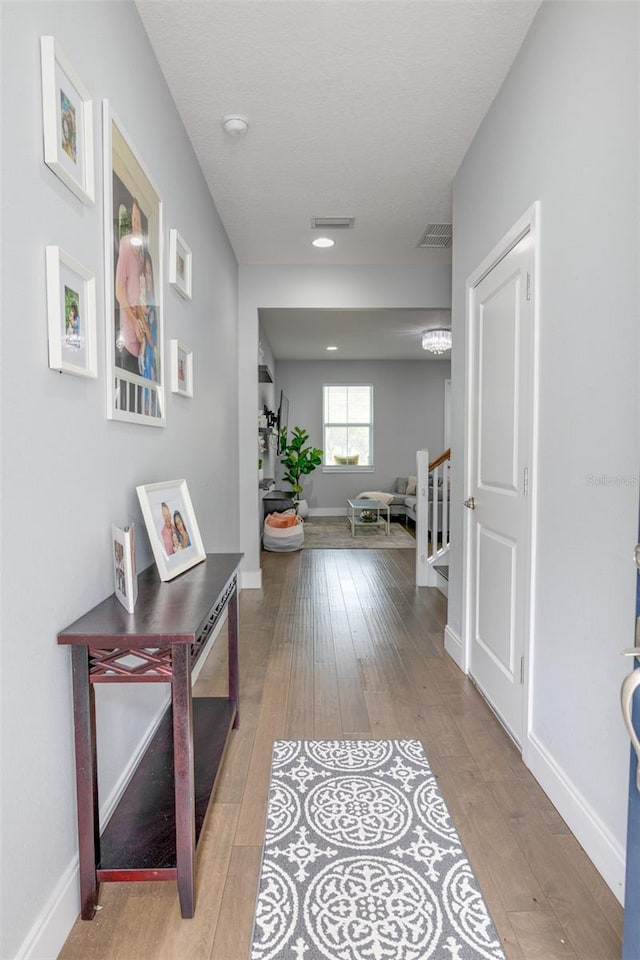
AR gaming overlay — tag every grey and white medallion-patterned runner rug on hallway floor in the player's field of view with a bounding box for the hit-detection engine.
[251,740,505,960]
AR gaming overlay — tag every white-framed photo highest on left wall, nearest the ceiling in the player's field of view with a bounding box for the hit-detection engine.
[40,37,95,204]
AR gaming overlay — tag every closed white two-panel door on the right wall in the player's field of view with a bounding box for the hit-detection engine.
[465,235,534,743]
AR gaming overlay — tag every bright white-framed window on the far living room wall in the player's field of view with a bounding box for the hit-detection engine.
[322,384,373,471]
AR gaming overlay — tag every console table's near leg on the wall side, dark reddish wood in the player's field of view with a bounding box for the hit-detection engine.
[71,646,100,920]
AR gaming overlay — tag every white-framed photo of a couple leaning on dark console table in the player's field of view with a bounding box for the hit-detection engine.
[136,480,206,580]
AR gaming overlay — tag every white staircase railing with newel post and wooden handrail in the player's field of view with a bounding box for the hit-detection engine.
[416,448,451,587]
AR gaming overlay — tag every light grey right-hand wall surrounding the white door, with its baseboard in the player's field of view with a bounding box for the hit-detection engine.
[449,2,640,895]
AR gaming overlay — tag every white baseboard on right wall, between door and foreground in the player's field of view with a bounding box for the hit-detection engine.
[523,733,625,904]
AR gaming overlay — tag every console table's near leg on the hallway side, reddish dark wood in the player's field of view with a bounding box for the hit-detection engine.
[171,643,196,919]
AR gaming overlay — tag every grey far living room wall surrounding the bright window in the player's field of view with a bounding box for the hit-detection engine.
[278,360,451,513]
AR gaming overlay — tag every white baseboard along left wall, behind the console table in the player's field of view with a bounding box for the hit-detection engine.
[15,610,227,960]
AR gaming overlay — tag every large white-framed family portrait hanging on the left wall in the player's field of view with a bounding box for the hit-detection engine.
[103,100,166,427]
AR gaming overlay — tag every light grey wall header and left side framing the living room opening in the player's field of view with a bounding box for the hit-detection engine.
[239,264,451,587]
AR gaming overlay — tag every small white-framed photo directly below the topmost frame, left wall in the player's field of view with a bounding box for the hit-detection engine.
[46,246,98,379]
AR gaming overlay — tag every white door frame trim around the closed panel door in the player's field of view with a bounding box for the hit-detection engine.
[460,200,541,760]
